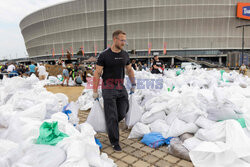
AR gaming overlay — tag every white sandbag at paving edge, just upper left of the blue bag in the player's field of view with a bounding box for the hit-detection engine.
[128,122,150,139]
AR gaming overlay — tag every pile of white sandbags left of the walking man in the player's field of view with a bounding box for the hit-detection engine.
[0,76,116,167]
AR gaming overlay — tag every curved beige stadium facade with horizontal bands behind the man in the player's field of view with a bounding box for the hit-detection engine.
[20,0,250,57]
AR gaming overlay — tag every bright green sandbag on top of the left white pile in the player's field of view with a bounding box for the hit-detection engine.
[36,122,69,146]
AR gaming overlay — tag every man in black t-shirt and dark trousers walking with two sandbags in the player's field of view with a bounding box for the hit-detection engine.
[93,30,136,151]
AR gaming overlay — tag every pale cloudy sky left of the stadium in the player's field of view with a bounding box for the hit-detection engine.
[0,0,70,60]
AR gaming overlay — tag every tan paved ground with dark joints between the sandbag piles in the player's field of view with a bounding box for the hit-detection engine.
[79,111,193,167]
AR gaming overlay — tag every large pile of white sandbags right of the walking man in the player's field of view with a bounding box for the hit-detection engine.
[124,69,250,166]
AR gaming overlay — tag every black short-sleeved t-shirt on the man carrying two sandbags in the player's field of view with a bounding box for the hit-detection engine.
[97,48,130,85]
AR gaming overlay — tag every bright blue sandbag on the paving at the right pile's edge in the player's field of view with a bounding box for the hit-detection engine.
[141,132,173,148]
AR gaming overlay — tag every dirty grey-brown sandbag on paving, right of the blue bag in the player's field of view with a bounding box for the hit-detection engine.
[168,138,190,161]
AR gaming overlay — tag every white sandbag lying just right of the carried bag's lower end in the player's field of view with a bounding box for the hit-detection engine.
[141,111,166,124]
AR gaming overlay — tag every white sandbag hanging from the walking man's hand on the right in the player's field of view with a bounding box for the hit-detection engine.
[125,94,142,127]
